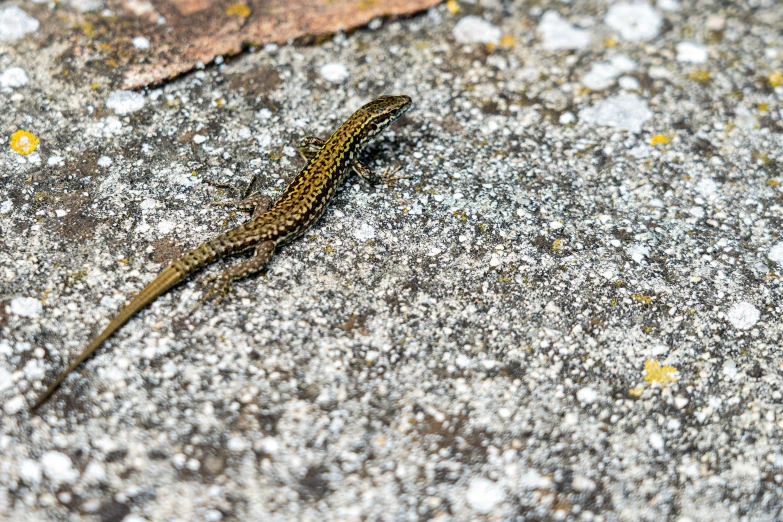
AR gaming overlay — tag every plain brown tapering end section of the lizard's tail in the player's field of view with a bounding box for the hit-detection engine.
[30,261,189,411]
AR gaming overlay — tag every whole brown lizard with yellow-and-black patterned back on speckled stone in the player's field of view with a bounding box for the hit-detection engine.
[30,95,411,411]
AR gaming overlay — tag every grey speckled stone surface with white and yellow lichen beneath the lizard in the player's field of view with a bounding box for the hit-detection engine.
[0,0,783,522]
